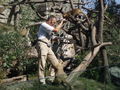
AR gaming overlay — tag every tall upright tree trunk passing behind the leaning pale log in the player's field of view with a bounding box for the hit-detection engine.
[98,0,109,83]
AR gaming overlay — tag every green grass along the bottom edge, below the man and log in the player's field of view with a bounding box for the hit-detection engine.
[0,78,120,90]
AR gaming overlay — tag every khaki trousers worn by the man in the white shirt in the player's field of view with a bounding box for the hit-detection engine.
[37,38,59,84]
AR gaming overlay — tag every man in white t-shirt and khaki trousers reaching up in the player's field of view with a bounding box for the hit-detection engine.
[37,15,65,84]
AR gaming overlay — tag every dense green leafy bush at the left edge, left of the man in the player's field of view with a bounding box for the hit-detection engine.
[0,31,27,69]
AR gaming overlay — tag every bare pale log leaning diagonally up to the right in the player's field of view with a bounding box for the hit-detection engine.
[66,42,112,83]
